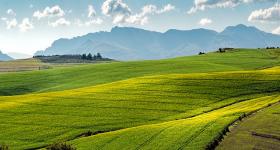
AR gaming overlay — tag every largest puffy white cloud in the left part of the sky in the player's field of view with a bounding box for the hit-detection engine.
[33,5,65,19]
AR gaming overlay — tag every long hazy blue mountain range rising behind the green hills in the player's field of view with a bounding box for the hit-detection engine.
[35,25,280,60]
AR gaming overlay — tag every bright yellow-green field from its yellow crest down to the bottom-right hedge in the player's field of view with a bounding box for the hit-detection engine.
[0,67,280,149]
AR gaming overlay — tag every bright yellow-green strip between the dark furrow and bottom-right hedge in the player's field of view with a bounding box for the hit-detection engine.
[71,96,280,150]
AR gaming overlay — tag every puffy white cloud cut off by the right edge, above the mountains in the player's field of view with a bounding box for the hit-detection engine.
[248,4,280,22]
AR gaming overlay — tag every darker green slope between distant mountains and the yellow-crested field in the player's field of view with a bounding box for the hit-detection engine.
[0,49,280,96]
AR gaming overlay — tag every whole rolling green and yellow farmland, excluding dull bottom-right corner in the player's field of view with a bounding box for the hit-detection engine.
[0,49,280,149]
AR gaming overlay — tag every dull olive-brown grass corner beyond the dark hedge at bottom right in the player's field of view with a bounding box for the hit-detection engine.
[217,103,280,150]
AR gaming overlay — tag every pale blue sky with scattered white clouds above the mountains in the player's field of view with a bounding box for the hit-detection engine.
[0,0,280,54]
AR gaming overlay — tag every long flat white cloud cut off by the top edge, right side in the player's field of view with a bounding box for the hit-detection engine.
[188,0,274,14]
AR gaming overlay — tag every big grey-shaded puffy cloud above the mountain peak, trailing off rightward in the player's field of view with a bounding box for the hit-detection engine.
[101,0,175,25]
